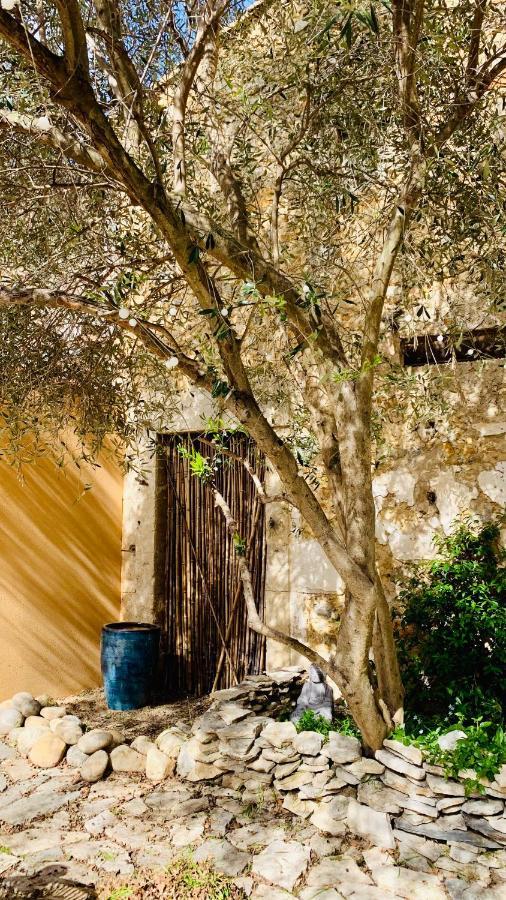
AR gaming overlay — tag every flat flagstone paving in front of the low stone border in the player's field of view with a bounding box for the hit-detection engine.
[0,742,506,900]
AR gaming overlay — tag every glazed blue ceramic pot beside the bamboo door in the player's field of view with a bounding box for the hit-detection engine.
[101,622,160,709]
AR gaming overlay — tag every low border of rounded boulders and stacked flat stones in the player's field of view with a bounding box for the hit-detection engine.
[0,668,506,862]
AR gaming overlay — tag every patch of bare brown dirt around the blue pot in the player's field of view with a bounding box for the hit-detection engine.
[61,688,212,740]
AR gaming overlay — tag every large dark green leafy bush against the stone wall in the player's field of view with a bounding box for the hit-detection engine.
[396,519,506,724]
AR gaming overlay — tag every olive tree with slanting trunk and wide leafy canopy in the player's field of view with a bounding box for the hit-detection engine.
[0,0,506,748]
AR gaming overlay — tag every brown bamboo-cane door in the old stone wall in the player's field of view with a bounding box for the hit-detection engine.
[159,433,265,696]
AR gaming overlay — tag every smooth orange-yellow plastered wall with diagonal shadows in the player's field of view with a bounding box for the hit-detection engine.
[0,448,122,700]
